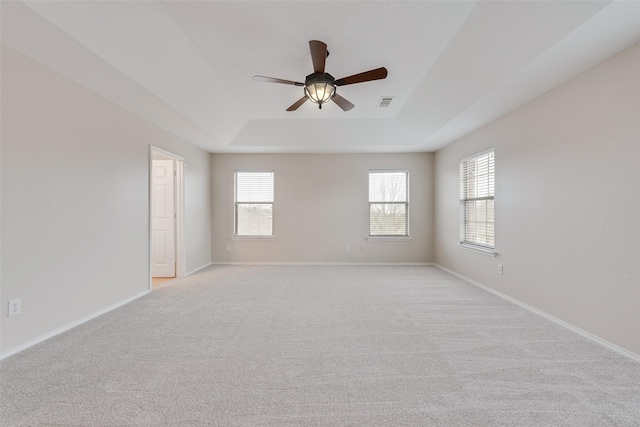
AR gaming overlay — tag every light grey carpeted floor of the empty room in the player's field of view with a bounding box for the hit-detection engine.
[0,266,640,427]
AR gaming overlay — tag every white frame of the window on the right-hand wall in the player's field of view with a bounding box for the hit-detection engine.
[458,147,496,256]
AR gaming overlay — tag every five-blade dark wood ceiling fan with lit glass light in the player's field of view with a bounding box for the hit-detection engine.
[253,40,387,111]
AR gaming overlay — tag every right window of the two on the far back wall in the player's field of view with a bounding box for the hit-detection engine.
[369,171,409,237]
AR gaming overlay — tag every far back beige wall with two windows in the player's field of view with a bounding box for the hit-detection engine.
[211,153,433,263]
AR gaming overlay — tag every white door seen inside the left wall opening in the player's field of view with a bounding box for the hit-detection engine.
[151,160,176,277]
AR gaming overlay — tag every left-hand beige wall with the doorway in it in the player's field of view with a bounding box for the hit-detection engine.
[0,46,211,354]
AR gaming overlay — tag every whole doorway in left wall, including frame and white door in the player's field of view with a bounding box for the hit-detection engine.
[149,146,184,289]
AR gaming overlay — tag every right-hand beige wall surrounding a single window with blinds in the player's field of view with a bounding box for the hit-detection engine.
[435,44,640,355]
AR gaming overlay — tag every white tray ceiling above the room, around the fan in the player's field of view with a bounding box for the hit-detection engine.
[1,1,640,153]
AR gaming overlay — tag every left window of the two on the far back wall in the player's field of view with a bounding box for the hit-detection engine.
[234,171,273,236]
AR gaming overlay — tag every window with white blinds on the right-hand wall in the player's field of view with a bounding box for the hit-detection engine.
[460,148,495,251]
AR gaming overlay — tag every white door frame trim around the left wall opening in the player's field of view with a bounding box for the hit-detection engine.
[148,145,185,290]
